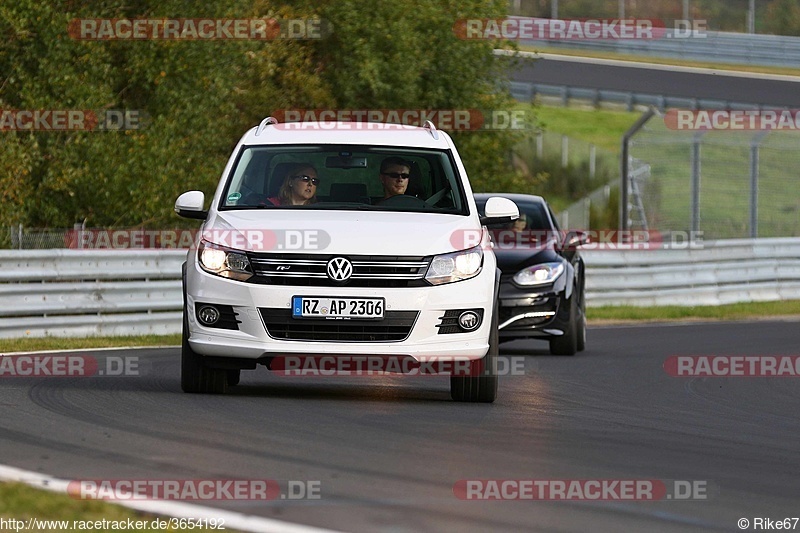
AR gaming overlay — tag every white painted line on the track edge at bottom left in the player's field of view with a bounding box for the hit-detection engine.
[0,465,335,533]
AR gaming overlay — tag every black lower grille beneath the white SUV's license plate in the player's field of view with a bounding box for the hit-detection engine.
[259,308,419,342]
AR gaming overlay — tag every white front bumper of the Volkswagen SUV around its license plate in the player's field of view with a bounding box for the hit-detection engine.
[186,256,495,361]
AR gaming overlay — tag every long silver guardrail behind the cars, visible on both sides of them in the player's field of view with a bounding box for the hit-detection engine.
[0,238,800,338]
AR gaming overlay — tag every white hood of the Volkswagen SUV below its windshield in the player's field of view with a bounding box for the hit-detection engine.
[202,209,482,256]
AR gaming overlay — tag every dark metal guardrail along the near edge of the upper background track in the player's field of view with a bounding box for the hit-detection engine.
[510,81,774,113]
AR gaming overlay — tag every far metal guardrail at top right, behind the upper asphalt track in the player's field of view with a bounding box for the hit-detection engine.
[511,24,800,68]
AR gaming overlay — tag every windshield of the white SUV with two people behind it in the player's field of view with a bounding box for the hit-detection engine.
[219,145,468,215]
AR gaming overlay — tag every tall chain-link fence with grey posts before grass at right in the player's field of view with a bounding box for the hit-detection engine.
[627,114,800,239]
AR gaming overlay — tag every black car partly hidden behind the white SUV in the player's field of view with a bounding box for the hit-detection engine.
[475,193,587,355]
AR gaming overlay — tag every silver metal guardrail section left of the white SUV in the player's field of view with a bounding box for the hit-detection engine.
[0,249,186,338]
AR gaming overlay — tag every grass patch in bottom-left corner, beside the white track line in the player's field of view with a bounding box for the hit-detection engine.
[0,483,191,531]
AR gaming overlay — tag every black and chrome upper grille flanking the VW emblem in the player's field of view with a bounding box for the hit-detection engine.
[248,253,431,287]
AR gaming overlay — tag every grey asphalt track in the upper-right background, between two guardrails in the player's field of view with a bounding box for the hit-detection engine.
[510,55,800,109]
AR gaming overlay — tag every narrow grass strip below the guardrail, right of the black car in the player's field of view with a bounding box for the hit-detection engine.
[586,300,800,324]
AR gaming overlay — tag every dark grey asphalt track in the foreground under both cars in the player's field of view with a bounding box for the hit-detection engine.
[0,321,800,532]
